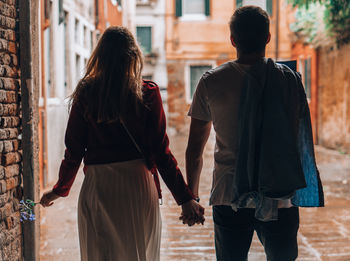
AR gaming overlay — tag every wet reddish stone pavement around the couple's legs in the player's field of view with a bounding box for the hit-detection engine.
[41,133,350,261]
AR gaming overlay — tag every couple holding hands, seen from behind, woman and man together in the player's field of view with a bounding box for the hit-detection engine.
[41,6,323,261]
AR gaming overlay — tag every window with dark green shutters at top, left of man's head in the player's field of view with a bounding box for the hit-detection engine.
[175,0,210,18]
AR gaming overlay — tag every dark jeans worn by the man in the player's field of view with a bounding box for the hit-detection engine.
[213,206,299,261]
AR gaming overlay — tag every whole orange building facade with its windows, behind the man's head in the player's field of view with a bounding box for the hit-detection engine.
[165,0,291,131]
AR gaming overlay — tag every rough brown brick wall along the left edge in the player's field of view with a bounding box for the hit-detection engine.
[0,0,22,260]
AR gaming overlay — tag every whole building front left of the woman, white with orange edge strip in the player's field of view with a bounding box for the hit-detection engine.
[40,0,95,187]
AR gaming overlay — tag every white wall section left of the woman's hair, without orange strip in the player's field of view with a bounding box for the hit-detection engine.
[47,0,95,185]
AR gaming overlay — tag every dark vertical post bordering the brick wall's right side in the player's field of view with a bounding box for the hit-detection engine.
[18,0,40,261]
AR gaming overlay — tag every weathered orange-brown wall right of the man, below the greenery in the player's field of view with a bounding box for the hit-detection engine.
[292,5,350,150]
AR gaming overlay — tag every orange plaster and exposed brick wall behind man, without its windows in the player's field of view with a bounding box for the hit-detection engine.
[165,0,292,131]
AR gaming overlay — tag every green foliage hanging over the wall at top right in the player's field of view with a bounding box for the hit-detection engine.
[289,0,350,47]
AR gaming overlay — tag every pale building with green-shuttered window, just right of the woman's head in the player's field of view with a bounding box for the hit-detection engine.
[135,0,168,97]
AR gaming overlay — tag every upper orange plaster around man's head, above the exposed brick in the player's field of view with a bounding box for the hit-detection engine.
[166,0,294,60]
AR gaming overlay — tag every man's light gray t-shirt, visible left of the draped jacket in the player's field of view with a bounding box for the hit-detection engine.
[188,61,292,208]
